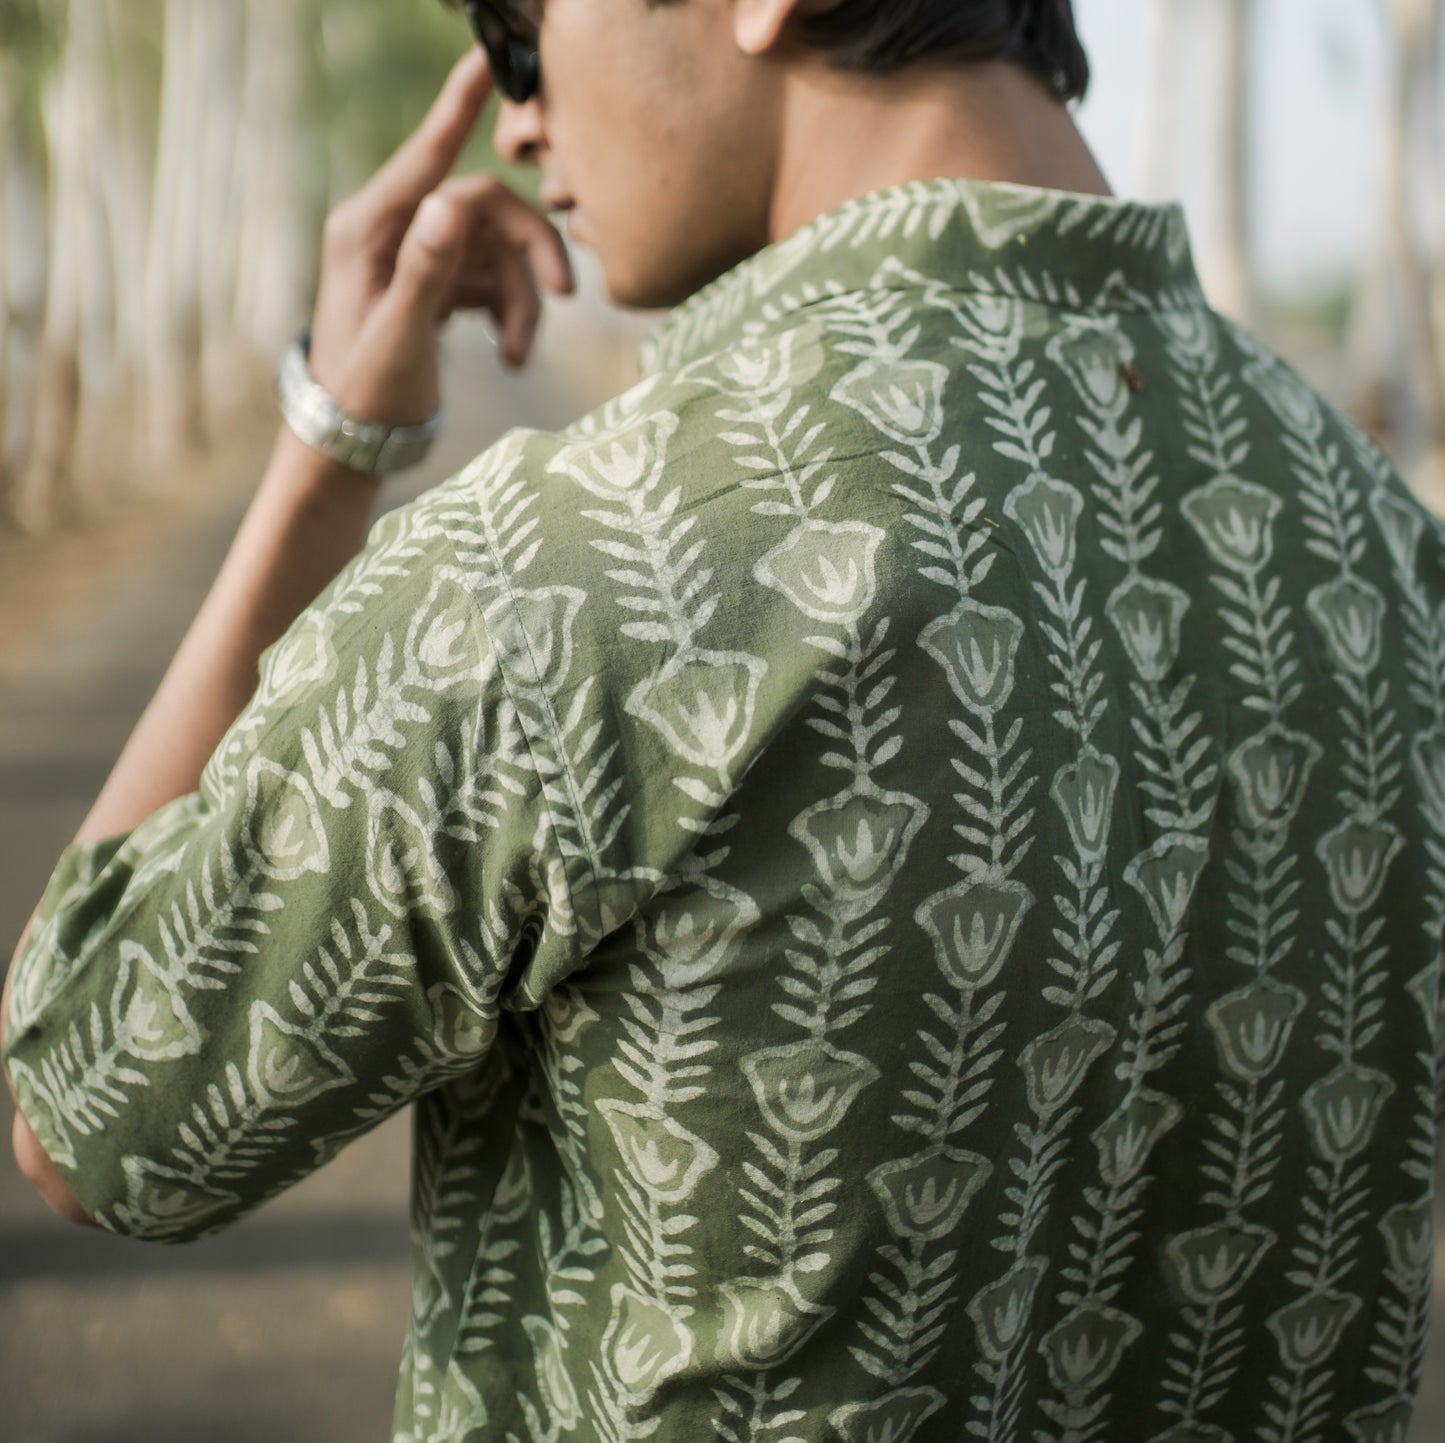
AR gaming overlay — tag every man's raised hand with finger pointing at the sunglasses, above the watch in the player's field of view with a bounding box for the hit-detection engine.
[311,49,574,425]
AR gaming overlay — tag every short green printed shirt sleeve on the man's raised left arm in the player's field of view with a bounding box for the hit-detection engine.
[4,482,575,1241]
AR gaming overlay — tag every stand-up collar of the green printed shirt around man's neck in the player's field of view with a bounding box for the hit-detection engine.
[642,179,1207,376]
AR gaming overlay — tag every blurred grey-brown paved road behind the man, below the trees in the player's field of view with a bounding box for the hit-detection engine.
[0,316,1445,1443]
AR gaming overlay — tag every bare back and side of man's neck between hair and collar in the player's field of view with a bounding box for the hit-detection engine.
[769,61,1110,241]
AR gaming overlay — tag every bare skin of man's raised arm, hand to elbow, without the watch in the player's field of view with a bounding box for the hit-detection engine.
[0,49,525,1218]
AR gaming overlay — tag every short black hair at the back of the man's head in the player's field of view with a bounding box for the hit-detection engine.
[805,0,1090,100]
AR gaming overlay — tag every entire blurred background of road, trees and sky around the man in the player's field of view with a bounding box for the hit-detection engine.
[0,0,1445,1443]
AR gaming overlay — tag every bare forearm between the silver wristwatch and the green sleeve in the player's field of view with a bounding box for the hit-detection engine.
[75,430,379,842]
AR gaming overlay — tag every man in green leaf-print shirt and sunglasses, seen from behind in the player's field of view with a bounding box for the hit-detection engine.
[6,0,1445,1443]
